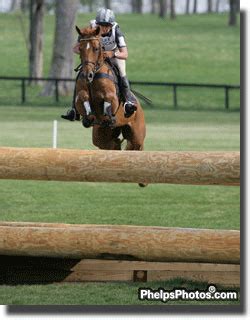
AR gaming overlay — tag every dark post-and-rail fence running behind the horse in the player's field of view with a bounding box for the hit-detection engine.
[0,76,240,110]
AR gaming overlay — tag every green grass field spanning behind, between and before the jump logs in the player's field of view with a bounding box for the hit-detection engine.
[0,11,240,305]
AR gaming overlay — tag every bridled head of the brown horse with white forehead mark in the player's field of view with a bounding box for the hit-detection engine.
[76,26,103,82]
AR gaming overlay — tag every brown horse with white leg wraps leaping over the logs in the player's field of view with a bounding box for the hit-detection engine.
[76,27,146,150]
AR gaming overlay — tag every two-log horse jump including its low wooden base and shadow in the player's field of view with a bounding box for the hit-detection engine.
[0,148,240,286]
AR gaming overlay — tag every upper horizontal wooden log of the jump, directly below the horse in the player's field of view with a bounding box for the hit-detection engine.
[0,148,240,185]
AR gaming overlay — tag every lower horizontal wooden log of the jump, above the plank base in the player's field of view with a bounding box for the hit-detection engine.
[0,222,240,264]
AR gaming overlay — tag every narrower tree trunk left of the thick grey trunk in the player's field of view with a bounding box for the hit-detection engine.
[29,0,44,82]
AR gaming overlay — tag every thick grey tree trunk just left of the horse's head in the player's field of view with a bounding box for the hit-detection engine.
[42,0,79,95]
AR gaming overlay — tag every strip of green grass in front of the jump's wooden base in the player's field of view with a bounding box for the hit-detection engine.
[0,279,240,306]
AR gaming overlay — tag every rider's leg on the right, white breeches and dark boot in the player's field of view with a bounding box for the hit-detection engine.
[112,58,137,118]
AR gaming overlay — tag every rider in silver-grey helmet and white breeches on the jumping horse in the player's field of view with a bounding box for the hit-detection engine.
[61,8,136,121]
